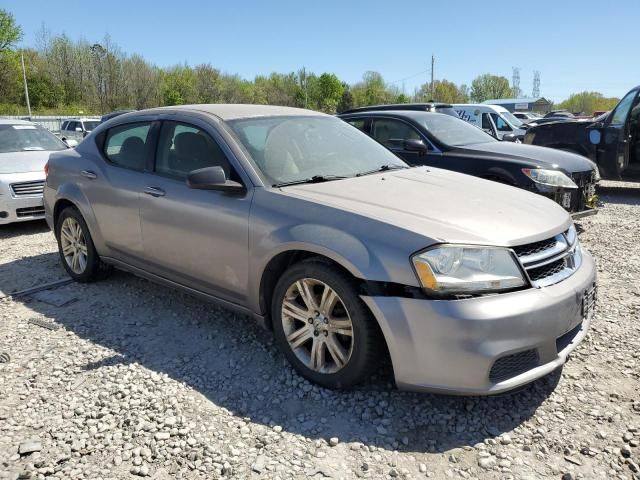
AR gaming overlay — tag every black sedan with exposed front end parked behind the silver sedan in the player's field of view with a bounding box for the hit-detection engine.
[340,110,599,218]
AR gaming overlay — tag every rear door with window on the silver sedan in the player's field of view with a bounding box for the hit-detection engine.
[79,122,153,265]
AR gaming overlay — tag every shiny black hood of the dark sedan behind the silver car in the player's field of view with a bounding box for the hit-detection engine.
[455,142,596,173]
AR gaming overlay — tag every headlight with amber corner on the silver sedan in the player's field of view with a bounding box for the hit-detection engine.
[411,245,526,294]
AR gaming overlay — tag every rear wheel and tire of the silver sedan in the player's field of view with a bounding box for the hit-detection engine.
[55,207,110,282]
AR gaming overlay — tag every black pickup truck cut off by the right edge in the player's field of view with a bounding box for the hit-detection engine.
[524,86,640,180]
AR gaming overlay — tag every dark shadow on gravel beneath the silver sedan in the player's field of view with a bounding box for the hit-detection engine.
[0,253,560,453]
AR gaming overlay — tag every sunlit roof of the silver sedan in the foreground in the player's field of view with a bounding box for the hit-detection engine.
[136,103,330,120]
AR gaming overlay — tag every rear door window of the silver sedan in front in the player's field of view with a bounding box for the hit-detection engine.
[104,122,151,171]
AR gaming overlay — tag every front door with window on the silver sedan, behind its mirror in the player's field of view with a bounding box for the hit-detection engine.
[140,121,253,304]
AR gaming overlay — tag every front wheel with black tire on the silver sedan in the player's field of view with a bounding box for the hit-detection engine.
[272,261,379,389]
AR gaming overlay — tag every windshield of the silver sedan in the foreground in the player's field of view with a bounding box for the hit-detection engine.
[227,116,406,185]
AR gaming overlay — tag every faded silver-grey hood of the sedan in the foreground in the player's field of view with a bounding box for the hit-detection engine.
[282,167,571,246]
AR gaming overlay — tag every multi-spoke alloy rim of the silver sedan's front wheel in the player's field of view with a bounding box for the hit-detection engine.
[281,278,354,374]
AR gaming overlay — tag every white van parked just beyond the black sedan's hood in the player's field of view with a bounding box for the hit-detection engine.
[453,103,527,143]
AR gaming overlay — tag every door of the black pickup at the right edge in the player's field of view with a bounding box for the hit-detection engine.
[596,90,638,179]
